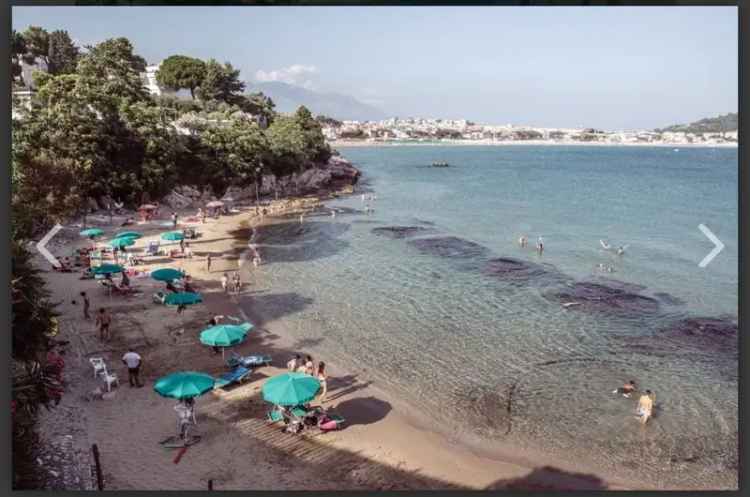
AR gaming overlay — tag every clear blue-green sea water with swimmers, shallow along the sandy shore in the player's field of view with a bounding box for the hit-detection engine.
[244,146,738,488]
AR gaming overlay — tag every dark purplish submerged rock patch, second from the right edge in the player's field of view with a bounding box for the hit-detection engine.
[551,282,659,315]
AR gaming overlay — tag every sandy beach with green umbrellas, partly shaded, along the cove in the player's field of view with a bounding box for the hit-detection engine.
[30,194,645,490]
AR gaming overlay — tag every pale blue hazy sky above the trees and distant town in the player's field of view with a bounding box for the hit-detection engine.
[12,7,738,129]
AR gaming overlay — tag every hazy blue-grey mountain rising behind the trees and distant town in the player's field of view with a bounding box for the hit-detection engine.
[248,81,388,121]
